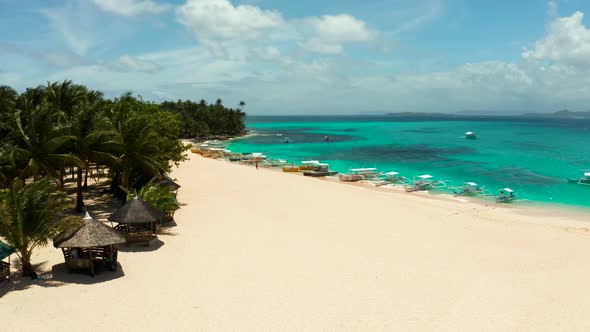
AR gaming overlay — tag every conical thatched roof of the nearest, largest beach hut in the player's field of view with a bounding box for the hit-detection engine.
[53,212,125,248]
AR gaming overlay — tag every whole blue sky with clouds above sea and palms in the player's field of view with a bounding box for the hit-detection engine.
[0,0,590,114]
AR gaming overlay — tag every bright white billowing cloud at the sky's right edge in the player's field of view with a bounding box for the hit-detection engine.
[522,12,590,67]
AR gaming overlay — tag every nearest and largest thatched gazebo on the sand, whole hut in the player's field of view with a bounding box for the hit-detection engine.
[53,212,125,276]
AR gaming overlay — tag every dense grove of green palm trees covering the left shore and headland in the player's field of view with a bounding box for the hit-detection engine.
[0,81,245,273]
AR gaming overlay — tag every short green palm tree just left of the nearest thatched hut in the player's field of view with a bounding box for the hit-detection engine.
[0,178,73,276]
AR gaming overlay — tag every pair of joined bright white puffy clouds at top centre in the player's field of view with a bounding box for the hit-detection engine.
[177,0,378,56]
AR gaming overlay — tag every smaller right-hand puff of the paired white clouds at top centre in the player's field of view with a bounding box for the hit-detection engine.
[301,14,377,54]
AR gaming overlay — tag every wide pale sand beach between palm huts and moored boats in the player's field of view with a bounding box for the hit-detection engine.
[0,154,590,331]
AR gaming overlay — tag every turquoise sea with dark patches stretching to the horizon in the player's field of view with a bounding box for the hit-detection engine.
[228,116,590,208]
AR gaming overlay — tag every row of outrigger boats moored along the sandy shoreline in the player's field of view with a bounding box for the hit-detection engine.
[191,139,590,203]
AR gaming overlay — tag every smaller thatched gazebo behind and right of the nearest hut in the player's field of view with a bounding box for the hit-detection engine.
[109,196,164,245]
